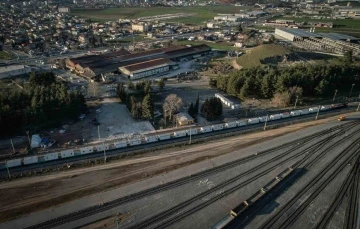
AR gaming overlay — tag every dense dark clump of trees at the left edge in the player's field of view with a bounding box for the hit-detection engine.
[0,73,86,136]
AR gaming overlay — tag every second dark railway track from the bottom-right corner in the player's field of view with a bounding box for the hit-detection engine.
[315,157,360,229]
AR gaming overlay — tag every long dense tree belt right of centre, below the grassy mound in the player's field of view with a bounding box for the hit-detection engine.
[209,64,360,99]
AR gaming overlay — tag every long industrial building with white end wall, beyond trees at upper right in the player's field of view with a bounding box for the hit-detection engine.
[275,28,360,55]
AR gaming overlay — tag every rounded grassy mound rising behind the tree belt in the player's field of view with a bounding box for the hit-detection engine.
[236,45,291,68]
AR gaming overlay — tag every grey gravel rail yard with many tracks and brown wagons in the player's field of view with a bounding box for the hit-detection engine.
[1,111,360,228]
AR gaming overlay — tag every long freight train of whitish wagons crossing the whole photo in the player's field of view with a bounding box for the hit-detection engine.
[0,103,347,168]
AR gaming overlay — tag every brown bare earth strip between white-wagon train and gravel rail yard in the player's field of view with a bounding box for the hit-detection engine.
[0,113,352,222]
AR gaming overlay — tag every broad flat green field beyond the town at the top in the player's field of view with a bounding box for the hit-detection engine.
[71,6,249,25]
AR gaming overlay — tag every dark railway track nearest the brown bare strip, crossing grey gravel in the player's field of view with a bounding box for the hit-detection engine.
[24,122,357,229]
